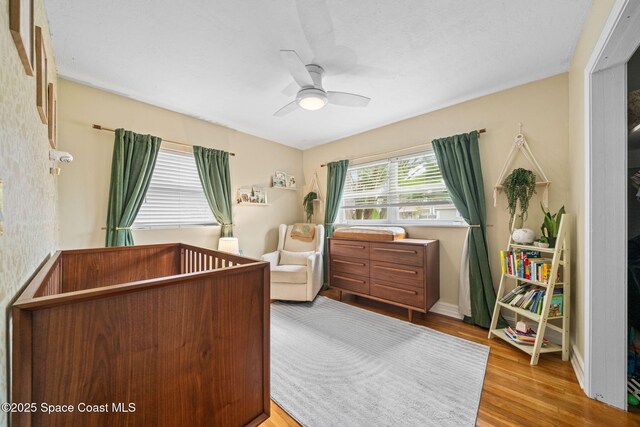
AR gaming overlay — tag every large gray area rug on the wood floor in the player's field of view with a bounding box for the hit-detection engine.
[271,296,489,427]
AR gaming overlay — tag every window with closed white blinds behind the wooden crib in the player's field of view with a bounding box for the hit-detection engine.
[133,149,216,228]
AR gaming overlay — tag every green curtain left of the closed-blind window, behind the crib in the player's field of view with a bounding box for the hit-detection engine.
[105,129,162,247]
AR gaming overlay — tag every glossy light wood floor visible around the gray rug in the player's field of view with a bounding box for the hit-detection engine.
[262,291,640,427]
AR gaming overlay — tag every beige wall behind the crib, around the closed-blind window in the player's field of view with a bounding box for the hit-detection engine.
[58,79,302,257]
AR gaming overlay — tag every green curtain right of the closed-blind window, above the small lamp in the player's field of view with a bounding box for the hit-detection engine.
[193,145,238,237]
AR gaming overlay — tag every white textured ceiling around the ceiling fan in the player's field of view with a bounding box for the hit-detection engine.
[46,0,590,148]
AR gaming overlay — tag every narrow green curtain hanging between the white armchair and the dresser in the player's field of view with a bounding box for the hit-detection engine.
[322,160,349,290]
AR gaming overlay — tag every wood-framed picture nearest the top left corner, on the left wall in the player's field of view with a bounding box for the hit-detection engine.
[9,0,34,76]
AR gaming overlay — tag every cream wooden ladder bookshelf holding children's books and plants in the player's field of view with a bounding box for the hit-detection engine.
[489,214,571,365]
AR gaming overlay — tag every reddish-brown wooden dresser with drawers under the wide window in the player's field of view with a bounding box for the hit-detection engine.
[329,237,440,321]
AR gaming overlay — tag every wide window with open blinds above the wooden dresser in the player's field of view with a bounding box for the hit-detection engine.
[339,149,462,224]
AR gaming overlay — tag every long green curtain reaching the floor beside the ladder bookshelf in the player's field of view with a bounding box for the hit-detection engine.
[433,131,504,328]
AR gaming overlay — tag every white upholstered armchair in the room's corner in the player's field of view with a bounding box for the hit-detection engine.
[262,224,324,301]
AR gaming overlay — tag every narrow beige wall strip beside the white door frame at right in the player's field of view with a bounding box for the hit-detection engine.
[568,0,614,359]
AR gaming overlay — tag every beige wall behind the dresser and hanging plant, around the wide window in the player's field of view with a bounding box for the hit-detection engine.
[304,74,569,304]
